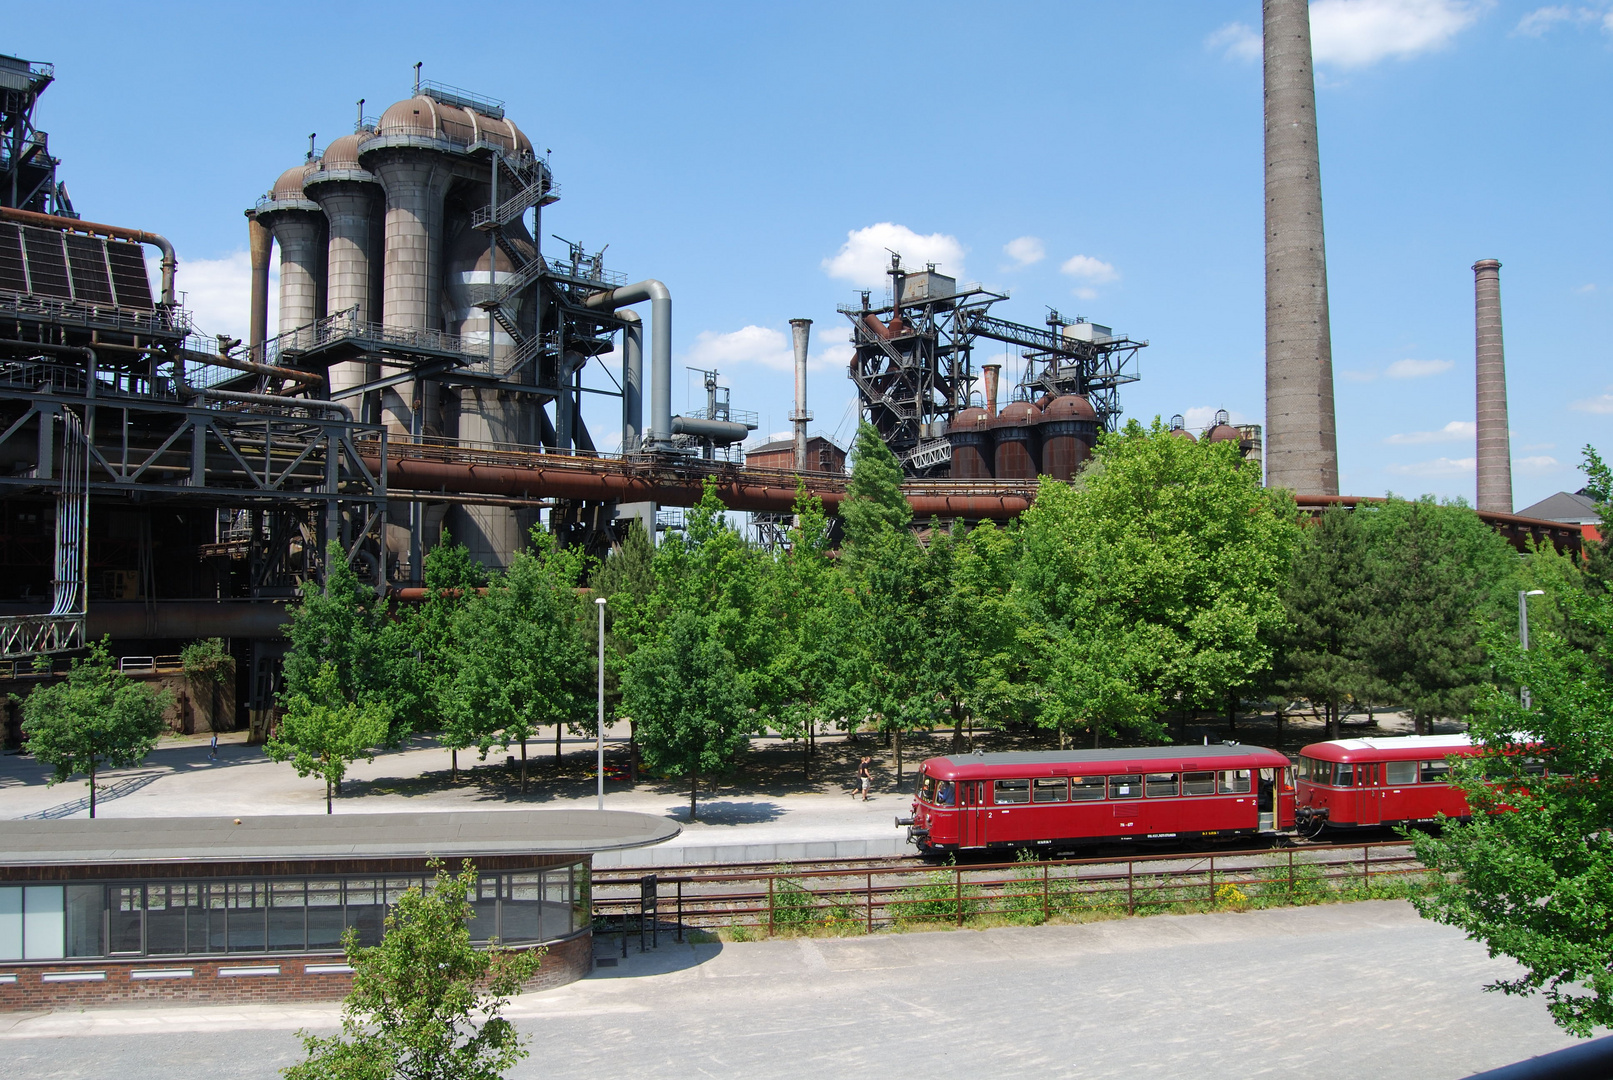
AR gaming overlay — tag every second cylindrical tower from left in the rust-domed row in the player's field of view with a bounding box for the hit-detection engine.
[303,135,384,398]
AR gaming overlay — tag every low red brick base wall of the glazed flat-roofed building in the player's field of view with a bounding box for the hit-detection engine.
[0,930,594,1011]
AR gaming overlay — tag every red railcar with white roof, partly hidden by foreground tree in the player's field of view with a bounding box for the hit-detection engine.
[1295,735,1478,833]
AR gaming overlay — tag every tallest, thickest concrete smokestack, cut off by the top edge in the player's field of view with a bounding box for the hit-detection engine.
[1263,0,1339,495]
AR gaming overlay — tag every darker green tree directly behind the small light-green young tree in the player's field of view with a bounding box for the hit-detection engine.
[281,542,401,745]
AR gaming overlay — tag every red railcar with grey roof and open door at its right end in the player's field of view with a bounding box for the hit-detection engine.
[897,745,1294,854]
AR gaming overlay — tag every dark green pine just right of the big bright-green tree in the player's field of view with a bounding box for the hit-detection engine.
[1276,506,1373,738]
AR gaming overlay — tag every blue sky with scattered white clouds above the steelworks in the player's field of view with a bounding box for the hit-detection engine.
[9,0,1613,508]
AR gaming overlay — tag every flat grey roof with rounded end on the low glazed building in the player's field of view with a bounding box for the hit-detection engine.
[0,809,681,867]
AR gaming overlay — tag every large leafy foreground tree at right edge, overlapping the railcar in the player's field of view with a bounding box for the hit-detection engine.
[1413,593,1613,1036]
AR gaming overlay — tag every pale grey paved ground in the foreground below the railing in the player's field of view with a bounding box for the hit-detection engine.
[0,901,1571,1080]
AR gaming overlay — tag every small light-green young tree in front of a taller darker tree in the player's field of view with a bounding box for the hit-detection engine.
[263,663,390,814]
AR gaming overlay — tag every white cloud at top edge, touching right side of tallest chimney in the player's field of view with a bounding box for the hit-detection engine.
[1310,0,1489,68]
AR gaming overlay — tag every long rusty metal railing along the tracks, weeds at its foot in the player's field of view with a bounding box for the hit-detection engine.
[592,841,1429,937]
